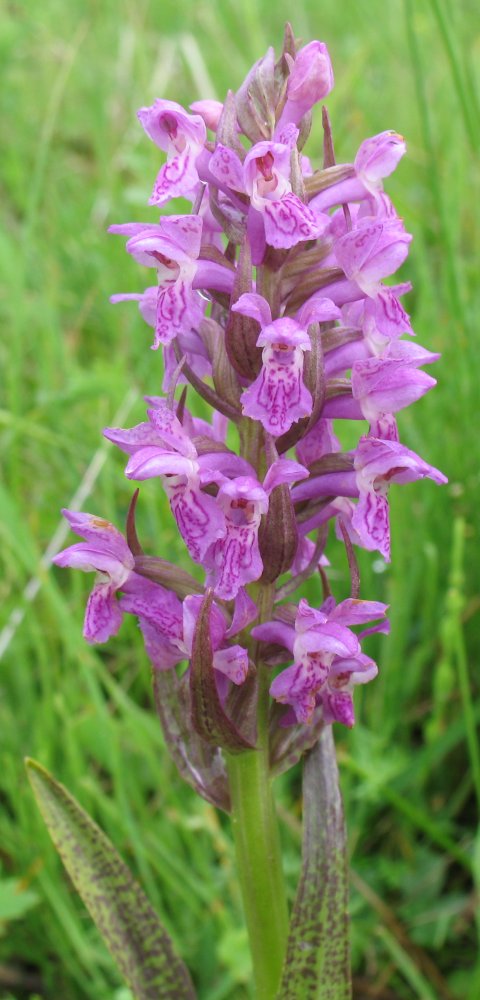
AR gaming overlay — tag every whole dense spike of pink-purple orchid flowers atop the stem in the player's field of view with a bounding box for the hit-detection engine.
[56,26,445,768]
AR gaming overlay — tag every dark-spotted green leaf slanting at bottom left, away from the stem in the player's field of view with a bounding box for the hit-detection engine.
[26,758,196,1000]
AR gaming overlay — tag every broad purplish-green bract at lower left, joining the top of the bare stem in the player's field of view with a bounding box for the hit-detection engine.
[153,670,230,812]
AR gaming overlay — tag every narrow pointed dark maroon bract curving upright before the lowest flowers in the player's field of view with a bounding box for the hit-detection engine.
[190,590,255,753]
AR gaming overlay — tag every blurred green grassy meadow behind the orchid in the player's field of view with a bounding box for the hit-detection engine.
[0,0,480,1000]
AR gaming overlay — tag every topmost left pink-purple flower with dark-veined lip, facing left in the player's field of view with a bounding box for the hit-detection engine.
[138,99,207,205]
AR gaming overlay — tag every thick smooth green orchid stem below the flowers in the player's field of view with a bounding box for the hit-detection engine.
[228,667,288,1000]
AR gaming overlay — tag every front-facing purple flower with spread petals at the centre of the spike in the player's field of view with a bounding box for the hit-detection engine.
[232,293,340,437]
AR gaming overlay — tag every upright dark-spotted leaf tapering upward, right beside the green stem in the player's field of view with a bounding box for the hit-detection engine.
[277,726,351,1000]
